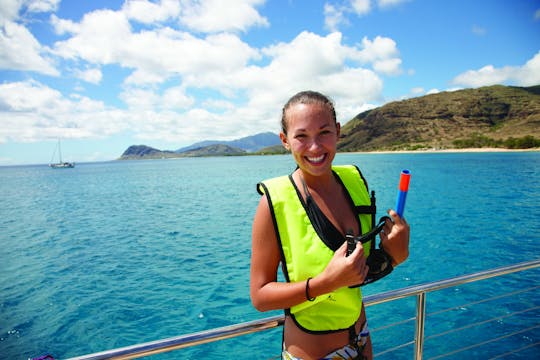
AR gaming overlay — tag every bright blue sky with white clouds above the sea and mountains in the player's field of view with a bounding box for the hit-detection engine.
[0,0,540,165]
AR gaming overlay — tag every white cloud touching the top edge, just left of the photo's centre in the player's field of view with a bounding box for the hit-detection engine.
[180,0,269,33]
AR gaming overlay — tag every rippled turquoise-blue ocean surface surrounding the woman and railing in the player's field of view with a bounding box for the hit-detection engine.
[0,152,540,360]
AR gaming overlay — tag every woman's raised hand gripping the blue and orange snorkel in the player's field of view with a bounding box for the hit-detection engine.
[379,210,410,266]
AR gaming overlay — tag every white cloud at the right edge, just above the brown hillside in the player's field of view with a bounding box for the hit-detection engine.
[452,52,540,87]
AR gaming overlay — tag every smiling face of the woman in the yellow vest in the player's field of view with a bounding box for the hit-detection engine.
[280,103,340,176]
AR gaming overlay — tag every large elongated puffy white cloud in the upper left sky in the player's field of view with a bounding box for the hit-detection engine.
[54,10,259,84]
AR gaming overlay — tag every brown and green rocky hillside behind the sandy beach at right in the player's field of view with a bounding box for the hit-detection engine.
[338,85,540,151]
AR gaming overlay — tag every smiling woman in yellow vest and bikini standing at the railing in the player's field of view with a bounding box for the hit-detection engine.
[250,91,409,359]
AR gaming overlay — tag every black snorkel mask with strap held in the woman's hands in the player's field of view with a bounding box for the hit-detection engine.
[345,216,394,288]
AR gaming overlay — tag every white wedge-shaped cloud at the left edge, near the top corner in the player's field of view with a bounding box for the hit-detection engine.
[0,22,59,76]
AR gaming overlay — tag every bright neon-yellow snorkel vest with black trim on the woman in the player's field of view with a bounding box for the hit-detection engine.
[257,165,375,333]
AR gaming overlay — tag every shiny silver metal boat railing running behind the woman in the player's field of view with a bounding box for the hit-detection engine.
[65,259,540,360]
